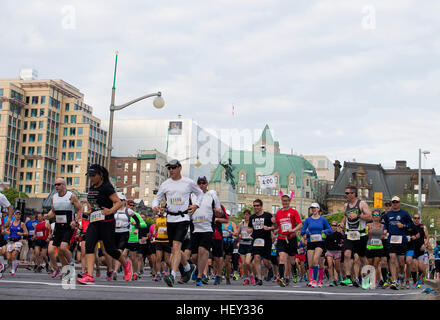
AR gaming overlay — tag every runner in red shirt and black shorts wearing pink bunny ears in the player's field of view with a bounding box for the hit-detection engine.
[273,194,302,287]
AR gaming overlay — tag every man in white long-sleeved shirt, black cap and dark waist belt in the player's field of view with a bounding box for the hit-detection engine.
[152,160,203,287]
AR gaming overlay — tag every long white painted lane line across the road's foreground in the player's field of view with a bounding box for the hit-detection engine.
[0,279,420,297]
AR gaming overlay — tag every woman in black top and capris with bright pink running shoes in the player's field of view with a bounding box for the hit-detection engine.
[77,164,133,284]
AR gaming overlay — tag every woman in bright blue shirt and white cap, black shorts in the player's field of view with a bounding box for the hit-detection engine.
[301,203,333,288]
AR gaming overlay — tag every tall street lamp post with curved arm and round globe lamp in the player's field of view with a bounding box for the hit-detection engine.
[106,51,165,170]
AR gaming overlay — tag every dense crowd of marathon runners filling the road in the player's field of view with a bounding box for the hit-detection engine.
[0,160,440,290]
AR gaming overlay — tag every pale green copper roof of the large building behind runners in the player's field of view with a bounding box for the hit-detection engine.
[210,150,317,188]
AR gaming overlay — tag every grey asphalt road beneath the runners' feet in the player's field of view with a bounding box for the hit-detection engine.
[0,268,431,301]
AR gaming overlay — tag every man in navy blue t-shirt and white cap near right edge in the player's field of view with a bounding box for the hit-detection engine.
[384,197,415,290]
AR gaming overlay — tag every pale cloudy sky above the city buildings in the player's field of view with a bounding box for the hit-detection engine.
[0,0,440,174]
